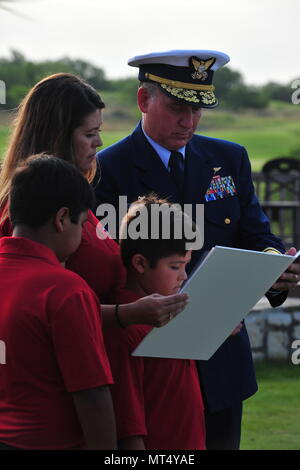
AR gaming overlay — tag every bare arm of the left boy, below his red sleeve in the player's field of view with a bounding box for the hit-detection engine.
[72,386,117,450]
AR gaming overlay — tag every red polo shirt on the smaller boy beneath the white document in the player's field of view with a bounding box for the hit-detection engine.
[104,291,205,450]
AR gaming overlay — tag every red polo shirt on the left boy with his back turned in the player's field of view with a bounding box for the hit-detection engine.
[0,237,112,449]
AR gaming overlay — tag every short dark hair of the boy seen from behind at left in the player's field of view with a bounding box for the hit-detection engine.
[9,153,95,228]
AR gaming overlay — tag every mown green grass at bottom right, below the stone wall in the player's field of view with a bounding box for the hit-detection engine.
[241,361,300,450]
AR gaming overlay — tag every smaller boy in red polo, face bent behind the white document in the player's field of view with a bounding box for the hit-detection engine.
[104,196,205,450]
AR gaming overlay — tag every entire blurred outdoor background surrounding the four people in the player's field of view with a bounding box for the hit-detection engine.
[0,0,300,449]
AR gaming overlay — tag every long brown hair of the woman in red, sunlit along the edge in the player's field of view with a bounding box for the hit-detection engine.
[0,73,105,221]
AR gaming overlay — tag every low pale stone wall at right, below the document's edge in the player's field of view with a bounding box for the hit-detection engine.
[245,298,300,360]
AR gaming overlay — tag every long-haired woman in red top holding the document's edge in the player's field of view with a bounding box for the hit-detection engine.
[0,73,187,326]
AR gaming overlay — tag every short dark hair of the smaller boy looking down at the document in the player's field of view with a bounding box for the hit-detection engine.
[119,193,196,268]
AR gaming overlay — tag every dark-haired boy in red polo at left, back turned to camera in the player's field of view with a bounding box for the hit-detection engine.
[0,155,116,449]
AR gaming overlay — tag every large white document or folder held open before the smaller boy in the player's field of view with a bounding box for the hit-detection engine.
[132,246,300,360]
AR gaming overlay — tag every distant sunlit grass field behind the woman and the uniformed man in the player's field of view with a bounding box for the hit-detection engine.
[0,105,300,171]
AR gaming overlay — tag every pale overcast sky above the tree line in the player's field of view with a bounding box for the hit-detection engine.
[0,0,300,85]
